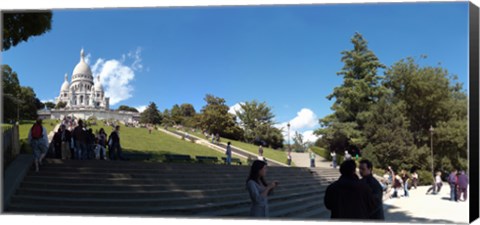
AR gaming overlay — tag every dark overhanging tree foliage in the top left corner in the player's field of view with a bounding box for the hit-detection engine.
[2,11,52,51]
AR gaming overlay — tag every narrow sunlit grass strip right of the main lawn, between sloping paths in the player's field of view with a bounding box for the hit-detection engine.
[172,128,286,166]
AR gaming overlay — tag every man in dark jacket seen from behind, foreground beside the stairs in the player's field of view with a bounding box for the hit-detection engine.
[324,160,377,219]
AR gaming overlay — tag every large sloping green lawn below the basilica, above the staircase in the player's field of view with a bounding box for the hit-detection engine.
[90,122,225,161]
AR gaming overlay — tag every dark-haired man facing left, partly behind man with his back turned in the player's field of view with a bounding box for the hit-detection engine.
[358,159,385,220]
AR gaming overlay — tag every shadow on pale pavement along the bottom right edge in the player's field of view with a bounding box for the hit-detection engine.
[383,204,458,224]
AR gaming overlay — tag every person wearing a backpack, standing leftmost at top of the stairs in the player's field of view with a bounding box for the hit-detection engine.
[28,119,48,172]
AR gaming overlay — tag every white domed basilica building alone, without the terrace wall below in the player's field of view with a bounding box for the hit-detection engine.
[55,49,109,109]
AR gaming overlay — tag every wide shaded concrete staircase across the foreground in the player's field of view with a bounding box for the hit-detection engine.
[6,159,339,219]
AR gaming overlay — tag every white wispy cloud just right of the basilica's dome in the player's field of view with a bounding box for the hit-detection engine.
[87,47,143,105]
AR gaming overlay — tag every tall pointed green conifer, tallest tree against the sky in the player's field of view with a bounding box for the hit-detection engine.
[315,33,387,152]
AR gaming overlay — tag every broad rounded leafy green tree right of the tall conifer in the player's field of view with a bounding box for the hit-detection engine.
[384,57,452,145]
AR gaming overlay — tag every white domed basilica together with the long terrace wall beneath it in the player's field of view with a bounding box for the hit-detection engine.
[37,49,140,123]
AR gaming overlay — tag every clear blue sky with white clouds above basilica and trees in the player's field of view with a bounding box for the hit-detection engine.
[2,2,468,142]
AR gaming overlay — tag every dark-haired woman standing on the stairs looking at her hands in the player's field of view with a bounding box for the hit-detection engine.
[247,160,278,217]
